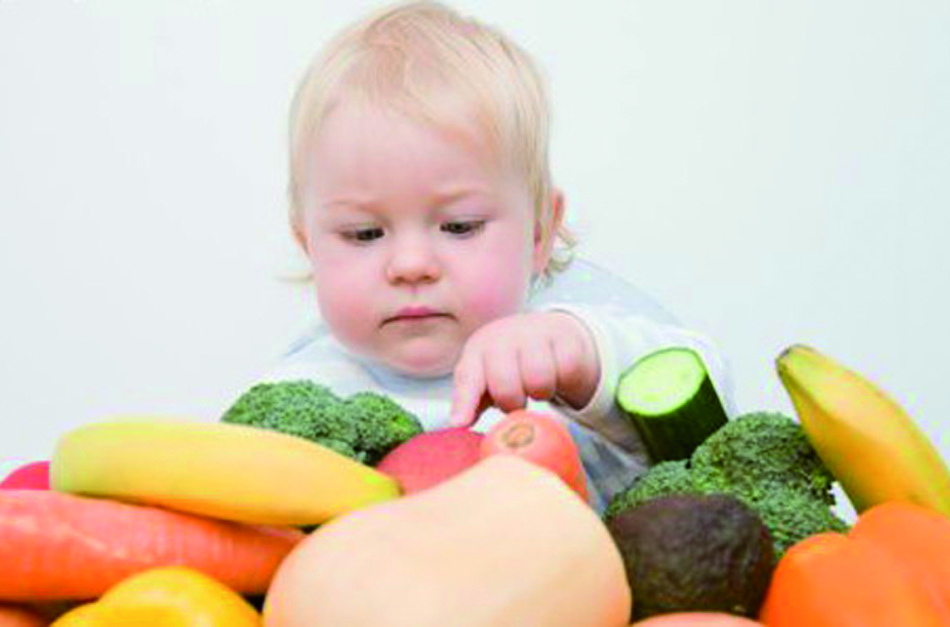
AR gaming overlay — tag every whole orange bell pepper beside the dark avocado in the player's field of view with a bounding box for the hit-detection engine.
[759,503,950,627]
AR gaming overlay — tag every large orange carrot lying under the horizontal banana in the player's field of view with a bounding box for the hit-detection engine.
[0,490,304,601]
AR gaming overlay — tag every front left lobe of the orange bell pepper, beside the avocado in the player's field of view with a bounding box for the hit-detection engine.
[759,533,947,627]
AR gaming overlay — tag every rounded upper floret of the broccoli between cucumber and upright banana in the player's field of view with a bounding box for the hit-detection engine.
[690,412,835,505]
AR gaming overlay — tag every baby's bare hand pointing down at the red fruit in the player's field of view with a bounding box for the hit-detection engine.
[449,311,600,426]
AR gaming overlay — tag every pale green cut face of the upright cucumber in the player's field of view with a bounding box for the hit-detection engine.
[617,347,706,416]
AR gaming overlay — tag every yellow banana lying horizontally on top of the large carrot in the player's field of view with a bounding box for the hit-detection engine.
[50,419,399,525]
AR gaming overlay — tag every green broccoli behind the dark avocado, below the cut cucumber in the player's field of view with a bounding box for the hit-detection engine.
[604,412,848,559]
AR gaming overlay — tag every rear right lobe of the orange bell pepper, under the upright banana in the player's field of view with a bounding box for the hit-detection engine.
[850,501,950,625]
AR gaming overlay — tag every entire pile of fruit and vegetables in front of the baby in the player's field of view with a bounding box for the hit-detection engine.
[0,346,950,627]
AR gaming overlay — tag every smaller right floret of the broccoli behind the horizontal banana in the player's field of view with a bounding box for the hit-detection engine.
[344,392,422,465]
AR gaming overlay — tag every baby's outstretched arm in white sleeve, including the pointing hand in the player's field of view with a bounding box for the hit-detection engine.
[450,304,734,451]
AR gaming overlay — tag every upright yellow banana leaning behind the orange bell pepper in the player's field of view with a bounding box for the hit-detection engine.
[776,345,950,517]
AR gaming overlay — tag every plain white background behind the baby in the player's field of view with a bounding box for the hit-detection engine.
[0,0,950,508]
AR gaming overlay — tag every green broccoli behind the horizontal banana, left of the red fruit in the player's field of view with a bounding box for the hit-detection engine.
[221,380,423,465]
